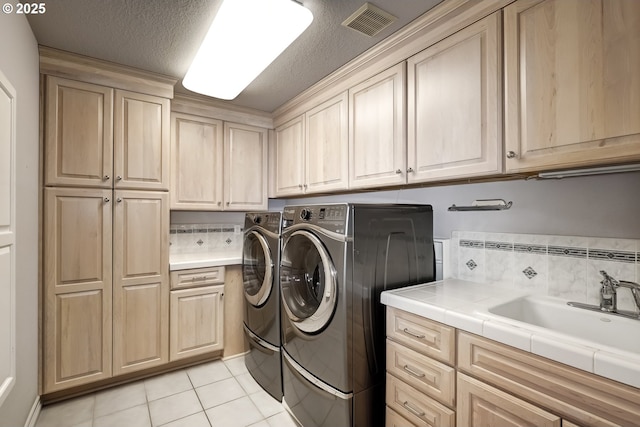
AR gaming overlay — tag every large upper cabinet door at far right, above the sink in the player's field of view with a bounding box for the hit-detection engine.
[504,0,640,172]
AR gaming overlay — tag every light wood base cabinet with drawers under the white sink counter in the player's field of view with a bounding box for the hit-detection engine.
[385,307,640,427]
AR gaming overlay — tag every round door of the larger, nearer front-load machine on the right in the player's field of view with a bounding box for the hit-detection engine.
[280,230,337,334]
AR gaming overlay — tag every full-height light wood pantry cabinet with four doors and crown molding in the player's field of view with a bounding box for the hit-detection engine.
[40,48,175,394]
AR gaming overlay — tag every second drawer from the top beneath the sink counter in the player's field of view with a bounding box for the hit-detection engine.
[387,340,456,407]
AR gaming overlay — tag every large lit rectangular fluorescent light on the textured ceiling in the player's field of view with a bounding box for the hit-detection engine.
[183,0,313,99]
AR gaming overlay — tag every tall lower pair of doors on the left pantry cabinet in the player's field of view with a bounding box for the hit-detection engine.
[42,187,169,394]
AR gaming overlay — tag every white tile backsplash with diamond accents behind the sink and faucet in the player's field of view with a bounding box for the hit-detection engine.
[450,231,640,310]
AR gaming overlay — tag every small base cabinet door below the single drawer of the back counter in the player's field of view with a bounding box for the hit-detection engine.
[169,285,224,361]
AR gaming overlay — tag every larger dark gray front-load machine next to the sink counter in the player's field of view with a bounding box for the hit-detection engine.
[280,204,435,427]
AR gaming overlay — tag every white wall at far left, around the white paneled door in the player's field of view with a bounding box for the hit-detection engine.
[0,13,39,426]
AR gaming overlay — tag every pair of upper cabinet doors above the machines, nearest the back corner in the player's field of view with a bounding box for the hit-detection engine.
[275,92,349,196]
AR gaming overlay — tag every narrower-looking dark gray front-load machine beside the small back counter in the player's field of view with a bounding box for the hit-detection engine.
[242,212,282,401]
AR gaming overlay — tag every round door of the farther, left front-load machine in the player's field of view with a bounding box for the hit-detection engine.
[242,231,273,307]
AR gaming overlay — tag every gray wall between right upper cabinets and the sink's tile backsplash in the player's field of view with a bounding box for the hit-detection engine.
[269,172,640,239]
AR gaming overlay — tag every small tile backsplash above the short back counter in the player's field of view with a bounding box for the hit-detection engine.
[169,224,243,254]
